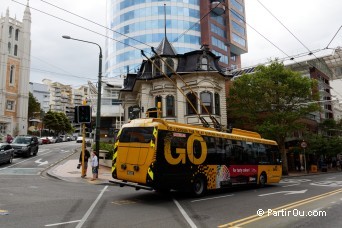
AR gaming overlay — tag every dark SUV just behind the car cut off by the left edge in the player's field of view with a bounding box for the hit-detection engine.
[11,135,39,157]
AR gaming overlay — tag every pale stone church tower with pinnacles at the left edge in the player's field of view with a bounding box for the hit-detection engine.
[0,3,31,136]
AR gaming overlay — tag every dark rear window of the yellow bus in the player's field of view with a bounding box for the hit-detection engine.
[119,127,154,143]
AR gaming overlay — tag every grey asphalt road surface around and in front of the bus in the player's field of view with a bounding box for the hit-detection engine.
[0,142,342,228]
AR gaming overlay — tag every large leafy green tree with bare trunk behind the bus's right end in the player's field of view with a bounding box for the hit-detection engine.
[227,61,319,174]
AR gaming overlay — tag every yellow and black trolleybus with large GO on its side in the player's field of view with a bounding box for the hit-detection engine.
[111,118,282,196]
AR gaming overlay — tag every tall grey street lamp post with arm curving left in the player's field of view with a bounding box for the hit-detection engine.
[62,36,102,169]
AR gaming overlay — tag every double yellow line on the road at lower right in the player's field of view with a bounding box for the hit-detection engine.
[218,188,342,228]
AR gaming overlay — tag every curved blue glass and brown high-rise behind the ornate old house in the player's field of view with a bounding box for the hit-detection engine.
[105,0,247,77]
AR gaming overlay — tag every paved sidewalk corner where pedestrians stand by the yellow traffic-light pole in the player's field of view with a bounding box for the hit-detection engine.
[47,150,113,184]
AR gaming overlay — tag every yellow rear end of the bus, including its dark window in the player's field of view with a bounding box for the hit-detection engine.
[116,127,157,184]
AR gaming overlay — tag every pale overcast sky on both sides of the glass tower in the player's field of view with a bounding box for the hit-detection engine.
[0,0,342,91]
